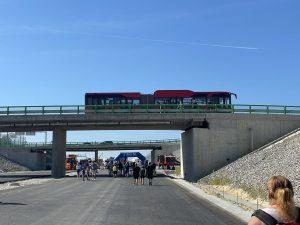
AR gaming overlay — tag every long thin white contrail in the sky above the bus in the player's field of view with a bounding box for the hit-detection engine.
[103,35,259,50]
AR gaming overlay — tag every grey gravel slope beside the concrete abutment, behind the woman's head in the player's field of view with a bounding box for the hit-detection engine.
[199,130,300,205]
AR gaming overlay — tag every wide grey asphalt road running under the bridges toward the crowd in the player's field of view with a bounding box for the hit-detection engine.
[0,173,244,225]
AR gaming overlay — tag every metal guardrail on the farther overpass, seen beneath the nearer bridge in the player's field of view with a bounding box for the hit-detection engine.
[0,139,180,148]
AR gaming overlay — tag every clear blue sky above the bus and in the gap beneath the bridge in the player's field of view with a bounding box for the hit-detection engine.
[0,0,300,157]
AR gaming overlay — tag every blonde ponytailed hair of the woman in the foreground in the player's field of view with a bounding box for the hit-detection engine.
[268,176,297,221]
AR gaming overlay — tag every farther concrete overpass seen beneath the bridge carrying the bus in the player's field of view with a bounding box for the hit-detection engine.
[0,139,180,170]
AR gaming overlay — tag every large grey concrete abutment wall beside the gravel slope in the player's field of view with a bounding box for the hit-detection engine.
[181,115,300,181]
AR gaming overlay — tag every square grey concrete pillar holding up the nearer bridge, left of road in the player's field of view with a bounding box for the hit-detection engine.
[52,129,67,178]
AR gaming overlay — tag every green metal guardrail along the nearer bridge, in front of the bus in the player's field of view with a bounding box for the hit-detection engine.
[0,104,300,116]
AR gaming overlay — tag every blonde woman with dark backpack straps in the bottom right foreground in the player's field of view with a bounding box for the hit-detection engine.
[248,176,300,225]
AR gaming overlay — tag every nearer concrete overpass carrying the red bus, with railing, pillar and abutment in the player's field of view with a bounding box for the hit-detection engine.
[0,105,300,180]
